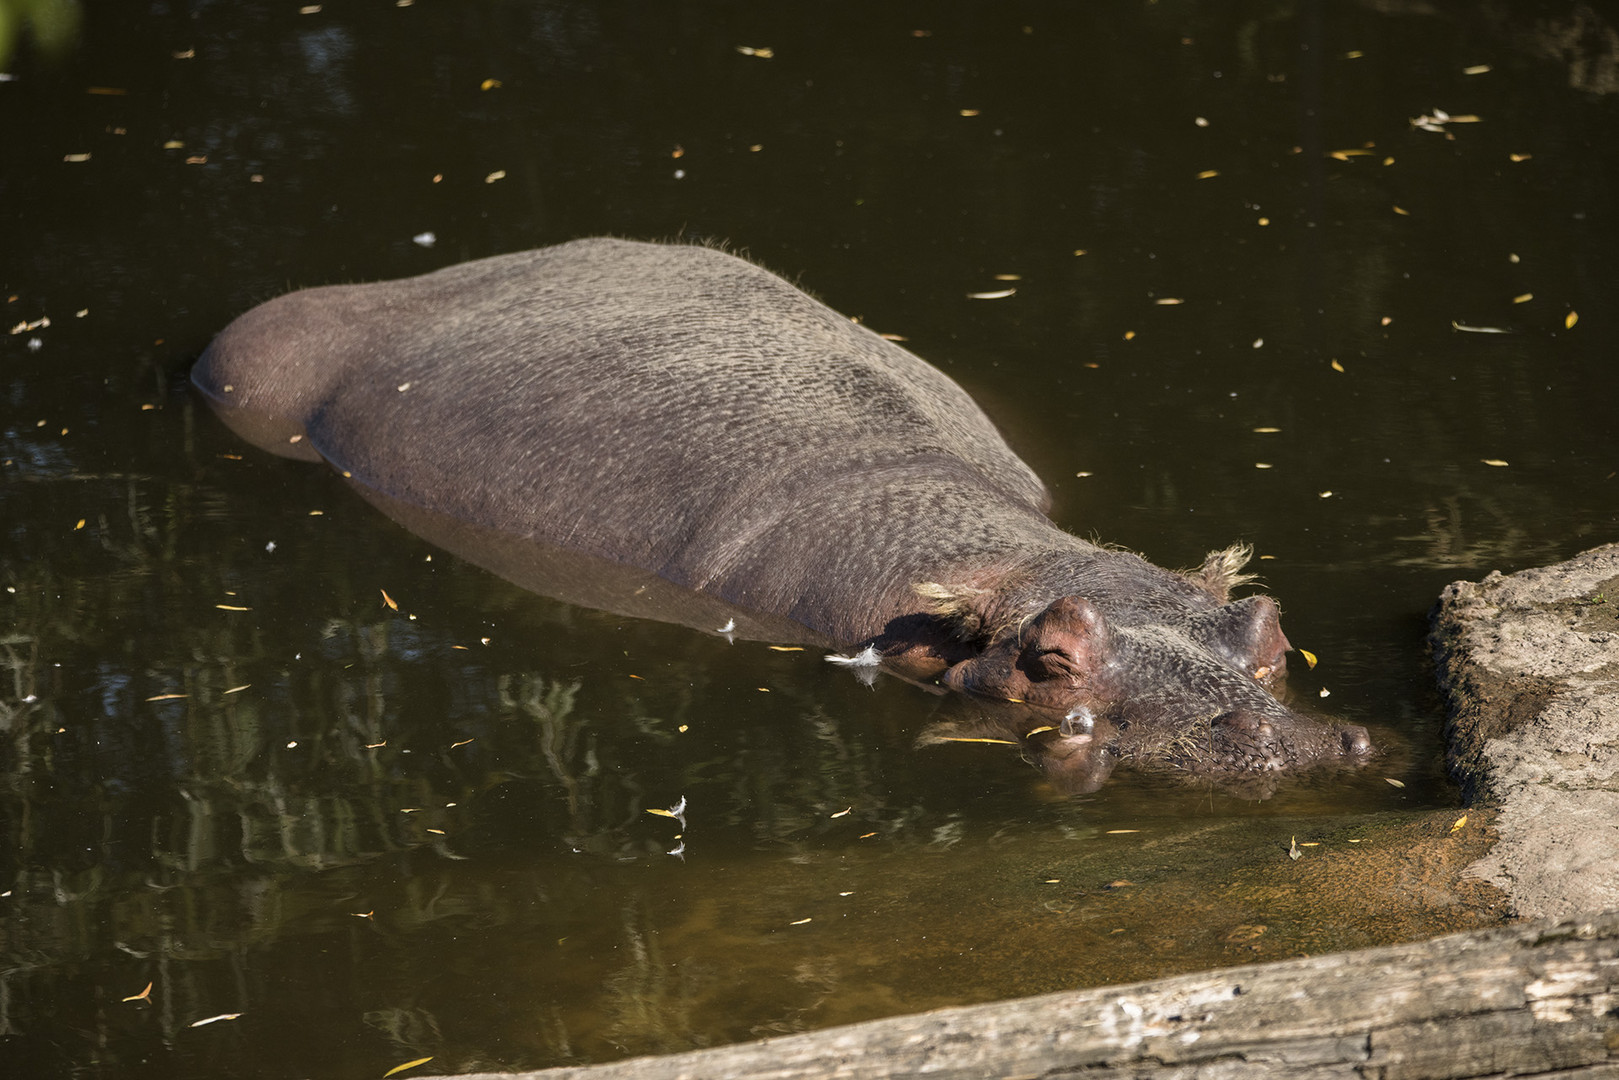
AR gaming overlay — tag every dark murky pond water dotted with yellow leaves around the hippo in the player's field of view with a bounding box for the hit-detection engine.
[0,0,1619,1078]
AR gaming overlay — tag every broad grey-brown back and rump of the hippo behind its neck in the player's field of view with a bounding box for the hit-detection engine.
[193,240,1046,625]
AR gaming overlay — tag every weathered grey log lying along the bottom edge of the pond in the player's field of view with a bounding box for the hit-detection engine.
[443,912,1619,1080]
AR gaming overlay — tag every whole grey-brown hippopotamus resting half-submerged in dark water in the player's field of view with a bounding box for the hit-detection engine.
[191,238,1371,789]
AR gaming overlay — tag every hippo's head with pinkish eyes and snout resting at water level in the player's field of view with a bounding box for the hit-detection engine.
[944,596,1371,786]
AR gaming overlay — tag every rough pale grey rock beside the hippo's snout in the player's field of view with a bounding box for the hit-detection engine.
[1433,544,1619,918]
